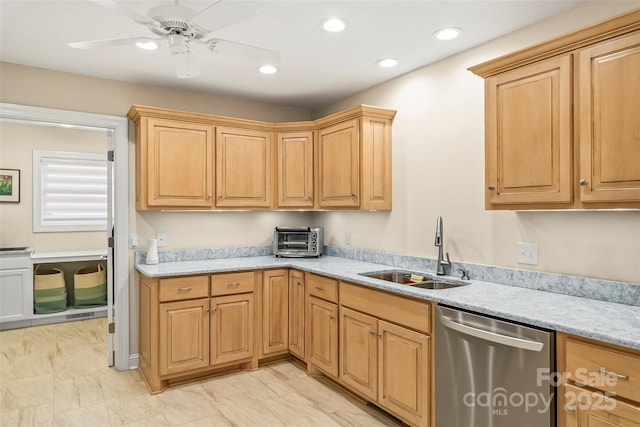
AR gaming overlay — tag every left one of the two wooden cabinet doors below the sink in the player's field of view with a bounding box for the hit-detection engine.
[340,307,378,401]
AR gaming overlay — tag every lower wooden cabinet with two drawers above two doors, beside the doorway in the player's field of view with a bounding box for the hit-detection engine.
[139,272,257,393]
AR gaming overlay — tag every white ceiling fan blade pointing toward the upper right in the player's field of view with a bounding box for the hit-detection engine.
[190,1,258,34]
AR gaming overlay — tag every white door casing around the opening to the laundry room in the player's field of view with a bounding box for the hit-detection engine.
[0,103,130,371]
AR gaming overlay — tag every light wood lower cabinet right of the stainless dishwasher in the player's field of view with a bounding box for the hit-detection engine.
[557,333,640,427]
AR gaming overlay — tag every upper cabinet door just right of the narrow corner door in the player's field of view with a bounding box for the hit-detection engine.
[318,120,360,207]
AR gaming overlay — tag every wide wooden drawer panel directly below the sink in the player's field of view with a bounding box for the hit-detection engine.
[340,282,431,334]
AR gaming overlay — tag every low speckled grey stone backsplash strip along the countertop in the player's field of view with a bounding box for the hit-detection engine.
[136,246,640,306]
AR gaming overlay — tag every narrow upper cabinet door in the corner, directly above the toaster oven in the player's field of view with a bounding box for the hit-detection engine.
[278,131,313,208]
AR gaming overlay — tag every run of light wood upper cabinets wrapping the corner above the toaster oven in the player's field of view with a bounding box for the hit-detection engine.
[128,105,396,210]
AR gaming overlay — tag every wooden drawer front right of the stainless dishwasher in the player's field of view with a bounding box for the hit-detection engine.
[566,340,640,402]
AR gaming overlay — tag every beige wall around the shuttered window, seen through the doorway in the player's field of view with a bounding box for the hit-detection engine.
[0,122,107,252]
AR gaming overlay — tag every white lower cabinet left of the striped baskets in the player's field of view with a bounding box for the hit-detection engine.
[0,249,33,323]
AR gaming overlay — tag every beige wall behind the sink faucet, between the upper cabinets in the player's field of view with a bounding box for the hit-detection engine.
[314,1,640,283]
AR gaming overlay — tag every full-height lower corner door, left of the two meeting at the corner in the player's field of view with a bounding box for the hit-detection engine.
[262,270,289,355]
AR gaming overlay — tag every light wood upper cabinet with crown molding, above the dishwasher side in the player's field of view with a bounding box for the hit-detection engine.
[469,8,640,209]
